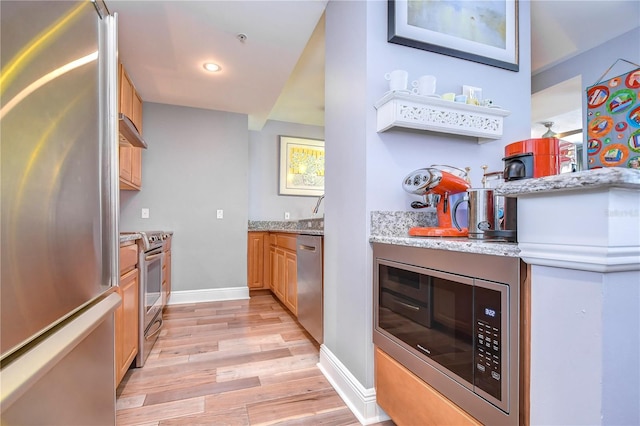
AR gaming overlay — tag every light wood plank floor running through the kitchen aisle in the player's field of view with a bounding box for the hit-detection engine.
[116,291,393,426]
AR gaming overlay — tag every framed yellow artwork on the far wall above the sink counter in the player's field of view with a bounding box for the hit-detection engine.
[279,136,324,197]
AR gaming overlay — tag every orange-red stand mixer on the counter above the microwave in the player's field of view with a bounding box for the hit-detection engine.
[402,166,471,237]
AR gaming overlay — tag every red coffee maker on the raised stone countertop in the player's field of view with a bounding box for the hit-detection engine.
[502,138,560,181]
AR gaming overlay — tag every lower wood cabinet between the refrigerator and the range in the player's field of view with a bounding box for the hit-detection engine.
[115,241,139,387]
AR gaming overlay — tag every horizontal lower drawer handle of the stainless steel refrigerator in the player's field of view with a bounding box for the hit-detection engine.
[0,289,122,411]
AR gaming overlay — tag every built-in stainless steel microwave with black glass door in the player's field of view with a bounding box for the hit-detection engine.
[373,243,521,424]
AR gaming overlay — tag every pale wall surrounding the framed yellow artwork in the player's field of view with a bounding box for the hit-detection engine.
[249,121,324,220]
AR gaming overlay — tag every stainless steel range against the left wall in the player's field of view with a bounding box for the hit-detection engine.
[123,231,169,367]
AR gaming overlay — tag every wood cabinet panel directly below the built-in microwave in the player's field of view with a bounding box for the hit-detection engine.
[375,348,481,426]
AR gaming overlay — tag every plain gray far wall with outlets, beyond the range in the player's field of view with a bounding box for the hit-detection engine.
[120,102,249,291]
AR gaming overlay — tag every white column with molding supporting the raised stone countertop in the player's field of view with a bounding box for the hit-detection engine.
[517,184,640,425]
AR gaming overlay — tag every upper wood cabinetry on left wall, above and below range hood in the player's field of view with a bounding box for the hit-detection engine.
[118,64,142,191]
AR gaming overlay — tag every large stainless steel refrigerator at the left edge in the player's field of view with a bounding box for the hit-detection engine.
[0,0,120,425]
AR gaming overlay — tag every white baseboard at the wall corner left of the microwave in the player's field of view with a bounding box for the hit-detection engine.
[318,345,389,425]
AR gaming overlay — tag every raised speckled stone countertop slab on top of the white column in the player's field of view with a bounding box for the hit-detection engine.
[495,167,640,196]
